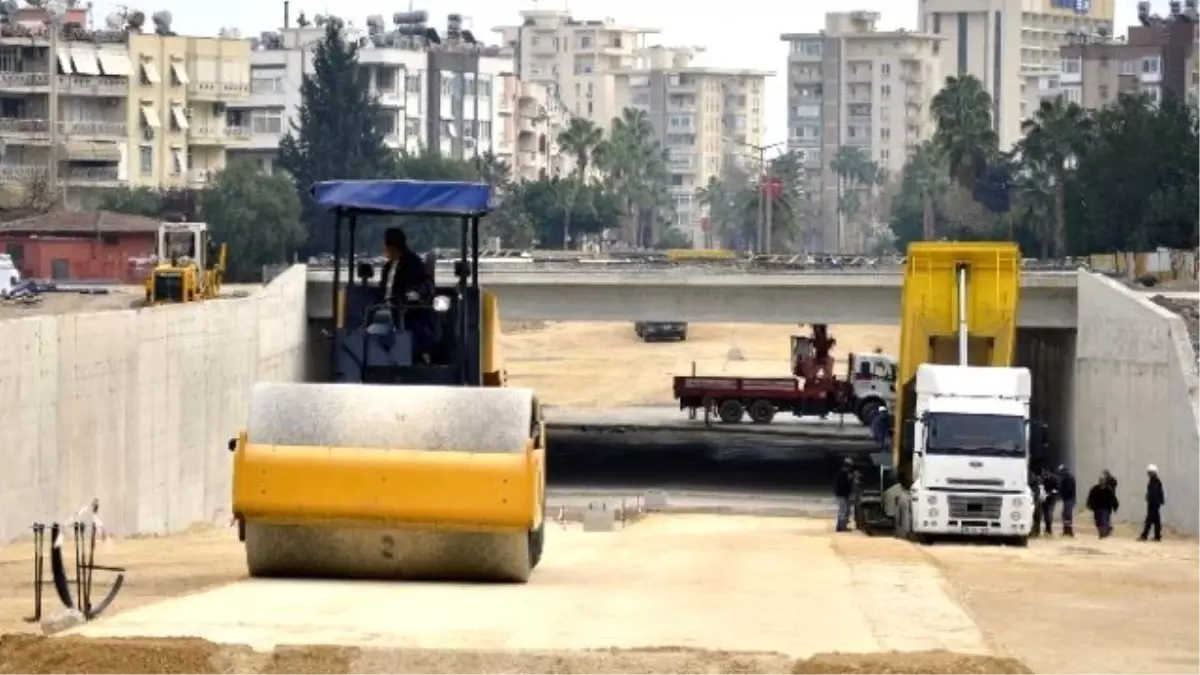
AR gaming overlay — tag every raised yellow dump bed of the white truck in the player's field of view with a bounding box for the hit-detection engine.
[892,241,1021,479]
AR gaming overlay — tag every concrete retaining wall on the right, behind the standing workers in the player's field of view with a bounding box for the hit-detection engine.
[1073,273,1200,533]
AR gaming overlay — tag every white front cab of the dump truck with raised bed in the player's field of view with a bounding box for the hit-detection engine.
[895,364,1033,542]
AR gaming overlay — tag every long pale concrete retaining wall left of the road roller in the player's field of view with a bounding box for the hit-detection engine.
[0,265,306,544]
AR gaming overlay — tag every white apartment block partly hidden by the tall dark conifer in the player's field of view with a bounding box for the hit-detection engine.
[228,12,514,169]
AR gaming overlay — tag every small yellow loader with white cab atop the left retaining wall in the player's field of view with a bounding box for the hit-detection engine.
[145,222,228,305]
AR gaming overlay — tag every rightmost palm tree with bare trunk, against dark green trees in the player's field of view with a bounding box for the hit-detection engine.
[1018,96,1092,257]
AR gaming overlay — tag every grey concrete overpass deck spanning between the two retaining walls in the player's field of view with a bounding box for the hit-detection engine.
[307,265,1078,329]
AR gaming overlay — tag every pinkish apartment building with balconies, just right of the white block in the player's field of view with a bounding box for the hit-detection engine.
[496,73,575,180]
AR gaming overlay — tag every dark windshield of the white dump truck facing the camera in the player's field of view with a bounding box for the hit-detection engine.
[925,412,1026,458]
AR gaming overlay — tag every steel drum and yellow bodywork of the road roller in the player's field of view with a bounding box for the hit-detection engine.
[233,293,546,583]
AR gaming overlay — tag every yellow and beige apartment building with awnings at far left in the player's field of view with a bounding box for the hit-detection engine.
[0,7,250,204]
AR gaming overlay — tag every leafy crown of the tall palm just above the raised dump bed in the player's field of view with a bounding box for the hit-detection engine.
[931,74,1000,190]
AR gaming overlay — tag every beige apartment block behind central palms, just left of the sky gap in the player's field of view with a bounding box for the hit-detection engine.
[616,46,774,249]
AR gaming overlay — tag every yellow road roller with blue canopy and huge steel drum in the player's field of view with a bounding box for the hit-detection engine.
[229,180,546,583]
